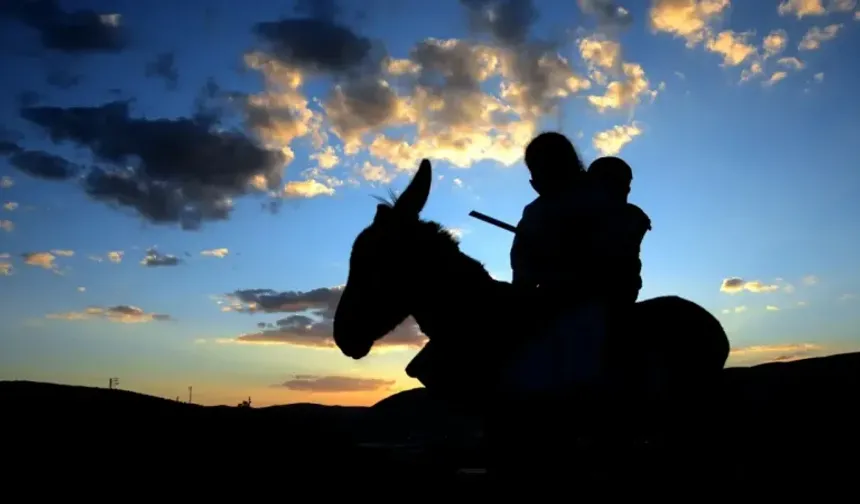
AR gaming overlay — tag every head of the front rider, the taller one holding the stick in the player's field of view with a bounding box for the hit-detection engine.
[525,131,585,194]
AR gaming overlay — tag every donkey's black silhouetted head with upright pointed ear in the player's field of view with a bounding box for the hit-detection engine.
[333,159,439,359]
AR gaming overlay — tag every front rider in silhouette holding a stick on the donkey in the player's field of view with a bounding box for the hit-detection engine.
[511,132,610,394]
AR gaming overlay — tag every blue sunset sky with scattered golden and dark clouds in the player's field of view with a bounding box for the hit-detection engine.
[0,0,860,405]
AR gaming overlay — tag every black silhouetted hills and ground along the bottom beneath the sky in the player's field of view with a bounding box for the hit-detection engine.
[0,353,860,492]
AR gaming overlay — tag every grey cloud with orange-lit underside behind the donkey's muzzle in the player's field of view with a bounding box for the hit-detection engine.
[219,287,427,348]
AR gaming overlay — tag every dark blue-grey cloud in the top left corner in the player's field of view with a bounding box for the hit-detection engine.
[0,0,127,53]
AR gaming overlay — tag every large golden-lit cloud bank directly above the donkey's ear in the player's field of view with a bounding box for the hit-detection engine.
[239,0,590,183]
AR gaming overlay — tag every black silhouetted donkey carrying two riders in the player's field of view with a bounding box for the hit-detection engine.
[333,159,729,420]
